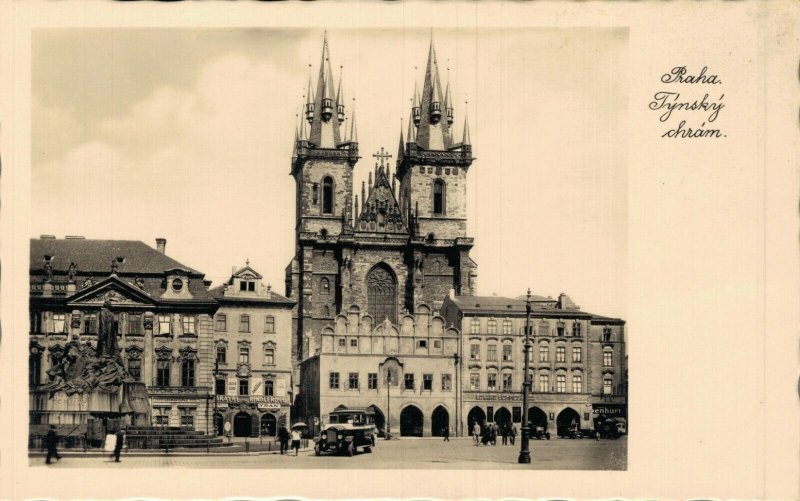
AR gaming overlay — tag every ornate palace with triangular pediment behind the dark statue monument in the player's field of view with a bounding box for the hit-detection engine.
[29,236,218,431]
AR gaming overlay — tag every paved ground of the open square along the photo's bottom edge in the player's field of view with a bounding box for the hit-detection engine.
[30,437,627,470]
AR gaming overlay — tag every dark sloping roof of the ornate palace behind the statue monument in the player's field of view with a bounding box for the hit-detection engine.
[30,238,202,275]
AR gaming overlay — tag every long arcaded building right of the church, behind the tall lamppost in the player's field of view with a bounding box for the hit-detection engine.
[442,294,627,436]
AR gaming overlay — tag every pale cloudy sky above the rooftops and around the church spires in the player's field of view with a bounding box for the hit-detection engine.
[31,28,628,317]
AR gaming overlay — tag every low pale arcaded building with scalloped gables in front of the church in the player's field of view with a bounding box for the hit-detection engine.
[298,304,459,437]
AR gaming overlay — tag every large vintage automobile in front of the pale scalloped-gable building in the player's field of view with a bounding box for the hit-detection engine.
[314,409,378,456]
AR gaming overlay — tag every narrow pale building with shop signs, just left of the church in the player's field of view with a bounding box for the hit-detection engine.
[210,262,294,437]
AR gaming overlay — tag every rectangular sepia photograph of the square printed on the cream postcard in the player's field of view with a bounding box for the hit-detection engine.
[29,28,629,470]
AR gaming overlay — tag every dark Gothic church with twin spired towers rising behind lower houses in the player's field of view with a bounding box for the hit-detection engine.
[286,32,477,360]
